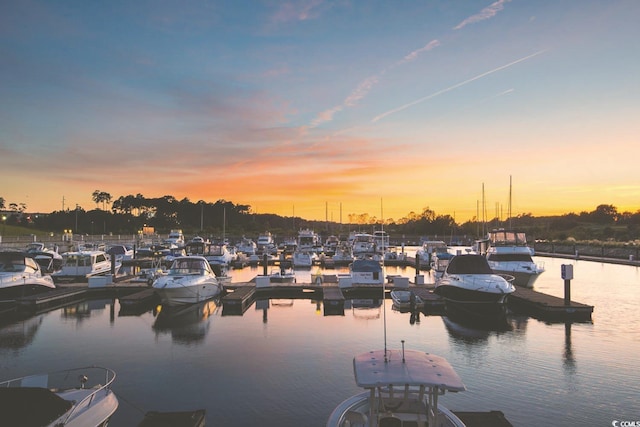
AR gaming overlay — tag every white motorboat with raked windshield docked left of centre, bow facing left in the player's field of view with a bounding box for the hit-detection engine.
[153,255,223,305]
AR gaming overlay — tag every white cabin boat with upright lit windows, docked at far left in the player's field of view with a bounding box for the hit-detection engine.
[51,250,122,282]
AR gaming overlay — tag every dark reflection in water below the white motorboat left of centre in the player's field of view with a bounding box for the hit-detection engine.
[152,299,221,345]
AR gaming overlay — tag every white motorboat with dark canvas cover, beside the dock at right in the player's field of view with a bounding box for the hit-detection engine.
[434,254,515,317]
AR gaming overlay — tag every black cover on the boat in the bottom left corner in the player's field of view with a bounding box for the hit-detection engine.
[0,387,72,427]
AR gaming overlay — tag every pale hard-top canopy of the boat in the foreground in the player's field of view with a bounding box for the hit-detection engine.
[353,350,466,392]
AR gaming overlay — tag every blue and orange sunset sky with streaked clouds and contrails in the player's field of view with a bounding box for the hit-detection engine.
[0,0,640,222]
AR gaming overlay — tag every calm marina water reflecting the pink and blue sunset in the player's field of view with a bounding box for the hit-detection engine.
[0,251,640,426]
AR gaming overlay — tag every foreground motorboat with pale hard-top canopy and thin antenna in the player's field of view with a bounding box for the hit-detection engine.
[327,345,466,427]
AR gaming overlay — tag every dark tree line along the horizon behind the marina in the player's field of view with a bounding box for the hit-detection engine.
[0,194,640,243]
